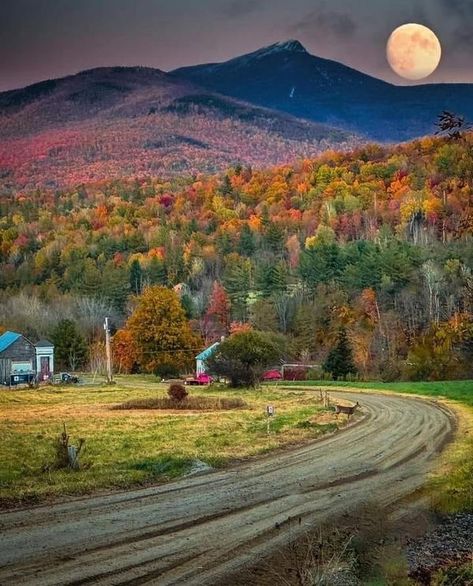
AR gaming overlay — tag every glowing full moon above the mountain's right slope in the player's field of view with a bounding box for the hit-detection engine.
[386,23,442,80]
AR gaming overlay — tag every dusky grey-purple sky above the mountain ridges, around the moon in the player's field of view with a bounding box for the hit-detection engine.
[0,0,473,91]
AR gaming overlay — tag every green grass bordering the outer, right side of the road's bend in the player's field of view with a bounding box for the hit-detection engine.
[284,380,473,513]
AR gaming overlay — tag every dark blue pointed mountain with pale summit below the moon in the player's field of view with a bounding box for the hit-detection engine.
[173,40,473,142]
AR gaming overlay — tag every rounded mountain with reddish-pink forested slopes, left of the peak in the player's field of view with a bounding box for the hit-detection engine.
[0,67,352,188]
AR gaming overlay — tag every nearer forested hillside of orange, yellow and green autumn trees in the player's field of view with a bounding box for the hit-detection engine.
[0,135,473,379]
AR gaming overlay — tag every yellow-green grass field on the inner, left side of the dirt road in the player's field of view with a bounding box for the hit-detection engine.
[0,376,336,506]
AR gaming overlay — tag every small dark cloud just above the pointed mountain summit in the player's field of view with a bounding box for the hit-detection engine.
[290,4,357,38]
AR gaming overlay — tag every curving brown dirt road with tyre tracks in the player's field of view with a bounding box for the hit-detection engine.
[0,393,453,586]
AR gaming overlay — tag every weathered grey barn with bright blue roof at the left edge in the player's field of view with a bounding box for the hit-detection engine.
[0,332,54,386]
